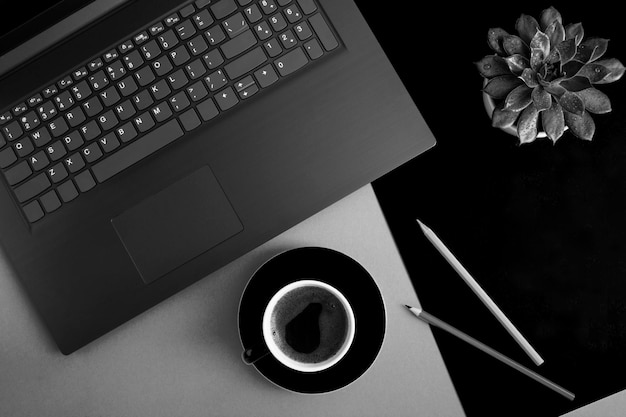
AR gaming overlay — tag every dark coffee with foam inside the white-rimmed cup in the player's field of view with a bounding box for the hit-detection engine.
[270,286,348,363]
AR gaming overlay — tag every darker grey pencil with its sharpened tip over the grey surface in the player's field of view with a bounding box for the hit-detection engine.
[406,306,575,401]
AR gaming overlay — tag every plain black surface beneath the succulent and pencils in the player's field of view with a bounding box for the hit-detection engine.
[357,0,626,416]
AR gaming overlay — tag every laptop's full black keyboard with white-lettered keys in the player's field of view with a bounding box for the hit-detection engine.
[0,0,339,223]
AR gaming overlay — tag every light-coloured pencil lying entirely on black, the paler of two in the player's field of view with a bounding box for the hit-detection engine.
[417,220,544,365]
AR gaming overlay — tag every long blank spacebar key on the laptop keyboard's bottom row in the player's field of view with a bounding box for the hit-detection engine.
[92,119,183,182]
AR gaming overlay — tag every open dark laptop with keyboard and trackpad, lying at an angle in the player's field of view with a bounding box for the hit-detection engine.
[0,0,435,354]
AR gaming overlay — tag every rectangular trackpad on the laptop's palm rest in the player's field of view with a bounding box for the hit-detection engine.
[111,166,243,284]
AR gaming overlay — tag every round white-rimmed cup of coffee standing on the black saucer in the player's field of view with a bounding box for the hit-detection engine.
[262,279,356,372]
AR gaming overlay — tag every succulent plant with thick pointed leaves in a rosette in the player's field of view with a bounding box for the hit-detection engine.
[475,7,624,144]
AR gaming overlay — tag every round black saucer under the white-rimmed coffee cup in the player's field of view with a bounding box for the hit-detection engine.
[239,247,386,394]
